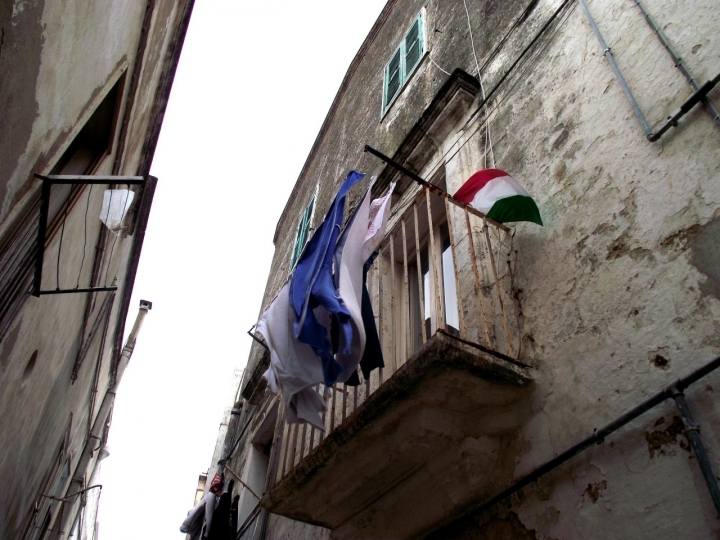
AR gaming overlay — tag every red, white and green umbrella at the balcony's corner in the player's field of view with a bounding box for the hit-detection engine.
[453,169,542,225]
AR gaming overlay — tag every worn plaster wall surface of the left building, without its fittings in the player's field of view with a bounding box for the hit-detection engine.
[0,0,188,538]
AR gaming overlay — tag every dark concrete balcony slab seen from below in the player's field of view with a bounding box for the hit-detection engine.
[262,332,532,540]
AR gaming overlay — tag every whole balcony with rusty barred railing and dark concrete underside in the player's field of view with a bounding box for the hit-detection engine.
[262,187,532,539]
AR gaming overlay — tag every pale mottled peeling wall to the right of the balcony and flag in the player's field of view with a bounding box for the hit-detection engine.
[430,1,720,538]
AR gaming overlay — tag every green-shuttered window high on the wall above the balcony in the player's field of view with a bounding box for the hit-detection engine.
[383,9,425,114]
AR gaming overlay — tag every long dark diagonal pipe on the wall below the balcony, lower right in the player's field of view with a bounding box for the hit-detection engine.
[450,356,720,515]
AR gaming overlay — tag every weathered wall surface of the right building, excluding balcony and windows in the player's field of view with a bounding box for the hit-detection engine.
[236,0,720,540]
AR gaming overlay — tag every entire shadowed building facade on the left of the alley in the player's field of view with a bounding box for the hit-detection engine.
[0,0,193,540]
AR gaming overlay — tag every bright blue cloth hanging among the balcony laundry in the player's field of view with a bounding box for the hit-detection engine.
[290,171,365,386]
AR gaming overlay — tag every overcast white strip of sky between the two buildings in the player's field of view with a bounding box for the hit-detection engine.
[99,0,386,540]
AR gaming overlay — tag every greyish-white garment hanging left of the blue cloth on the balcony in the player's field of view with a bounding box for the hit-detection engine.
[257,283,327,431]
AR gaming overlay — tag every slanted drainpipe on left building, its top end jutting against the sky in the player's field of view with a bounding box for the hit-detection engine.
[60,300,152,531]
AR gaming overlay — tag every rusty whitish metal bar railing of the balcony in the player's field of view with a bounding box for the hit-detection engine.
[268,184,519,487]
